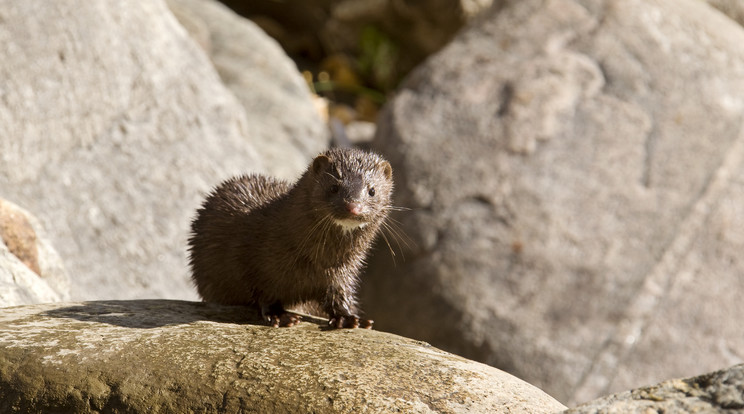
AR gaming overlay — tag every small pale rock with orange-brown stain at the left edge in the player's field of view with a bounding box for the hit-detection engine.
[0,199,70,307]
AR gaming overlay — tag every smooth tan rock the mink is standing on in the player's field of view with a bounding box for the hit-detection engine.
[0,300,565,413]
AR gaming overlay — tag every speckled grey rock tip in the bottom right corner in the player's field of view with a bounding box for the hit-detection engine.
[564,365,744,414]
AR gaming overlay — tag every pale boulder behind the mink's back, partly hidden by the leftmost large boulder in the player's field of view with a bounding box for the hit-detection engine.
[167,0,330,180]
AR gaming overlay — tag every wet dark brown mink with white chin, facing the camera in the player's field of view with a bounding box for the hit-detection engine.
[189,148,393,327]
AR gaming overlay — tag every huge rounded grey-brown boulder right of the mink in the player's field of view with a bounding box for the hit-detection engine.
[362,0,744,404]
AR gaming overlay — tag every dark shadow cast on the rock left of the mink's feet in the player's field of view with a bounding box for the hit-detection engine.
[44,299,264,329]
